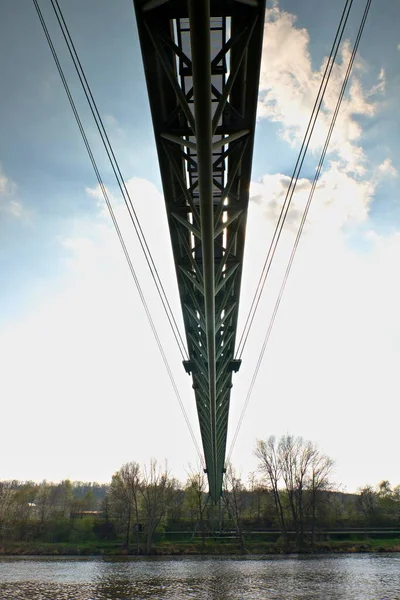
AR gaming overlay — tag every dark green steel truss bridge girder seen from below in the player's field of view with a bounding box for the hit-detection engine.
[133,0,265,502]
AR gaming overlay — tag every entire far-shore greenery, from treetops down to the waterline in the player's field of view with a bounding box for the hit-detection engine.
[0,434,400,556]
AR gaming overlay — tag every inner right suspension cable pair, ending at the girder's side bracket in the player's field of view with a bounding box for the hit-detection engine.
[236,0,353,358]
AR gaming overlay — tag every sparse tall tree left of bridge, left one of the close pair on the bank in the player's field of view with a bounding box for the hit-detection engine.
[109,462,142,553]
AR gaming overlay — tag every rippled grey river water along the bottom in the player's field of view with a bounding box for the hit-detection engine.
[0,554,400,600]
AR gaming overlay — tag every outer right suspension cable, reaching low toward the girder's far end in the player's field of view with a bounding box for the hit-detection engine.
[227,0,372,461]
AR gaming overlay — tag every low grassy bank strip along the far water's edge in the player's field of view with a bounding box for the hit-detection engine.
[0,539,400,556]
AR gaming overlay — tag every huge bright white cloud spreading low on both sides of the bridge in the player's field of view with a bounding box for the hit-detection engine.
[0,163,400,490]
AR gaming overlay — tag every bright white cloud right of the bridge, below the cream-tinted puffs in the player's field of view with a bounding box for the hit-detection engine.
[231,177,400,491]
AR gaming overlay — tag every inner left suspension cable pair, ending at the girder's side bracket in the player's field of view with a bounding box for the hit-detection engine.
[50,0,188,360]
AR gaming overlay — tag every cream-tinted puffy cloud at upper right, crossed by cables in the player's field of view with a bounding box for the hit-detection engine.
[258,2,385,174]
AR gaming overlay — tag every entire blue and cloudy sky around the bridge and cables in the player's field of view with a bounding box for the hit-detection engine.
[0,0,400,492]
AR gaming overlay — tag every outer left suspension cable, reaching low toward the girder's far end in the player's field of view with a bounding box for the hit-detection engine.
[33,0,204,465]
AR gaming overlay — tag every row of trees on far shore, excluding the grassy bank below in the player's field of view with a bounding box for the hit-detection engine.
[0,435,400,553]
